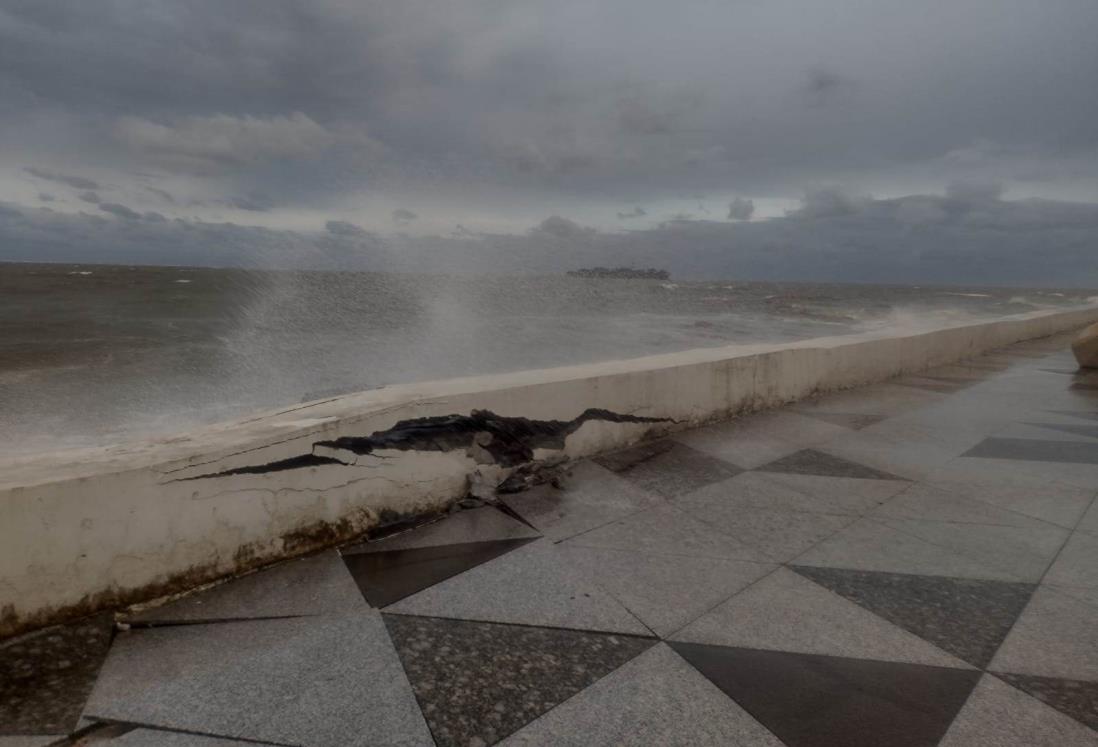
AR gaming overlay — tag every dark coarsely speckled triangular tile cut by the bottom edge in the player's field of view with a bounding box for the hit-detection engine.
[384,614,657,747]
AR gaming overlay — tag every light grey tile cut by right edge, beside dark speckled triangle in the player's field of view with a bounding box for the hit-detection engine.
[989,586,1098,681]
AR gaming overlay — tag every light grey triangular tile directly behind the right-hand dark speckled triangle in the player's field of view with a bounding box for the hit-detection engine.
[796,519,1021,581]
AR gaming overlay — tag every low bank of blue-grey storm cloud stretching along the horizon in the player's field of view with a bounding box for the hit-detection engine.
[0,189,1098,288]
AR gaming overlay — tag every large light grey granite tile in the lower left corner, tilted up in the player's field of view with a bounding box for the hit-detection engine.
[86,607,432,747]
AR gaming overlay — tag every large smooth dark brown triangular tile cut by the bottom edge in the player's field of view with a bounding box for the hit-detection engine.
[671,643,981,747]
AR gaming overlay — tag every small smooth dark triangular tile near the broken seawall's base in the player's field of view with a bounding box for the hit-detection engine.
[343,537,535,607]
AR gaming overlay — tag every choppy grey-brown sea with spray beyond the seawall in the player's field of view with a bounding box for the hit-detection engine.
[0,264,1095,454]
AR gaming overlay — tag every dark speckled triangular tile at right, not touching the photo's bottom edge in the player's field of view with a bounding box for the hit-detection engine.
[793,566,1035,668]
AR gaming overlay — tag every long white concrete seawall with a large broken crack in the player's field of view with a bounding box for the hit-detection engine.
[0,305,1098,636]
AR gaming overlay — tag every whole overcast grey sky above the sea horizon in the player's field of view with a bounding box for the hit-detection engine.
[0,0,1098,285]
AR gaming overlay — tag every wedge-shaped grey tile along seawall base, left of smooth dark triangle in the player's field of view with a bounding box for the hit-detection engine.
[125,550,362,623]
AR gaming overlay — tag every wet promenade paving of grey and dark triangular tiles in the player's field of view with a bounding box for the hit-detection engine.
[0,329,1098,747]
